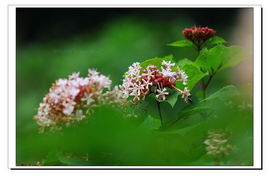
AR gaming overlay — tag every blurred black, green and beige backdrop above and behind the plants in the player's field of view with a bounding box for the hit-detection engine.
[16,8,253,163]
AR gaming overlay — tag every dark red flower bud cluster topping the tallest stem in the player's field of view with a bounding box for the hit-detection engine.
[182,27,216,43]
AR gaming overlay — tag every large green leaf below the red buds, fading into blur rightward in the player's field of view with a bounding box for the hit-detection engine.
[195,45,245,74]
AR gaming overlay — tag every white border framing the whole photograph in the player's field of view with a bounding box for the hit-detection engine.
[7,4,263,170]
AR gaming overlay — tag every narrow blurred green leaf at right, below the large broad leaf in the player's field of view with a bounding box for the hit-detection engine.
[201,85,240,102]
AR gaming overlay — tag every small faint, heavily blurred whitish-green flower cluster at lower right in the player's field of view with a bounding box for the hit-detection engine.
[204,130,234,157]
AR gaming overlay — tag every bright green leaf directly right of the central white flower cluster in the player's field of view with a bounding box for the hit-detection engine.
[176,64,207,90]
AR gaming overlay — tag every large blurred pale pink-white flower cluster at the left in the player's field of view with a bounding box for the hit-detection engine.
[34,69,123,131]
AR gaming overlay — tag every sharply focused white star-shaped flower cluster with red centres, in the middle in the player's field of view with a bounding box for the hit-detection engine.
[122,61,190,102]
